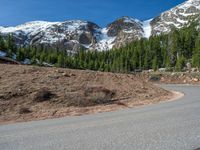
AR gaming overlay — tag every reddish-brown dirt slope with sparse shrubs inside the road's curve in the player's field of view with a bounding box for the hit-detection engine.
[0,64,171,123]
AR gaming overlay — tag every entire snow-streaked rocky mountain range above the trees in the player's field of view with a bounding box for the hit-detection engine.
[0,0,200,51]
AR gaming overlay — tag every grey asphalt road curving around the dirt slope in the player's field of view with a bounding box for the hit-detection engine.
[0,85,200,150]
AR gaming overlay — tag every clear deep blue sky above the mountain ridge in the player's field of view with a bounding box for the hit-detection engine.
[0,0,185,27]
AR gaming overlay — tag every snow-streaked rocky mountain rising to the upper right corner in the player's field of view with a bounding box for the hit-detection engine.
[151,0,200,35]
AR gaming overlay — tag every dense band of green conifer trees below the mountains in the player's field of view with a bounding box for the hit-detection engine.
[0,22,200,72]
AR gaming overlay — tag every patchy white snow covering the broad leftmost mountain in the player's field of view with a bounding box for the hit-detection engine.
[0,20,87,44]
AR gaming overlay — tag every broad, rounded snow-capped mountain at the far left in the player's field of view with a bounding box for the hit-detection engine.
[0,20,101,50]
